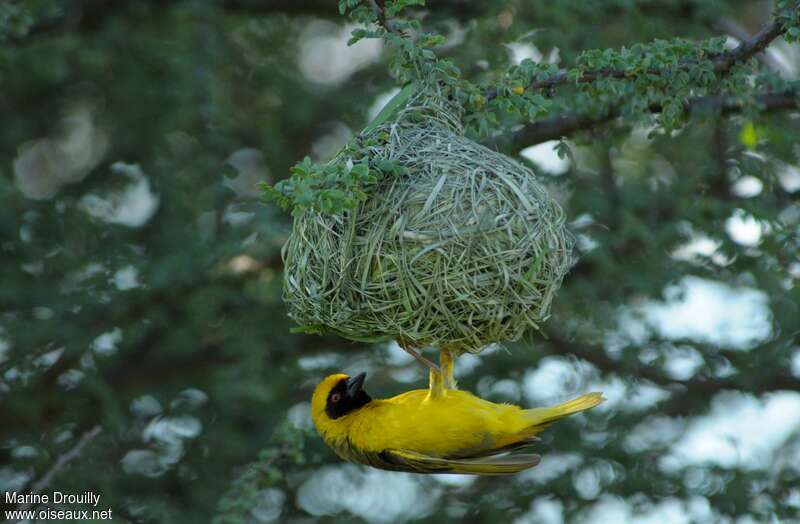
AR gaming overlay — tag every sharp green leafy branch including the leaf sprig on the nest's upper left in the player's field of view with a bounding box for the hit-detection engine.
[263,0,800,214]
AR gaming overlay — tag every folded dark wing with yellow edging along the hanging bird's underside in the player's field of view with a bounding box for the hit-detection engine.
[381,449,542,475]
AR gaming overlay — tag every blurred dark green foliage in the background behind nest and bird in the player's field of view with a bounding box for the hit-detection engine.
[0,0,800,523]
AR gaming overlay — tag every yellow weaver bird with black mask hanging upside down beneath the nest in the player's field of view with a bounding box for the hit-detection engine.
[311,370,605,475]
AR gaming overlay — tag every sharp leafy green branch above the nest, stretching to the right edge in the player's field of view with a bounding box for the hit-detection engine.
[340,0,800,145]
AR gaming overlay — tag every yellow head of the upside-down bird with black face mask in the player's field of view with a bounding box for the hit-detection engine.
[311,373,372,433]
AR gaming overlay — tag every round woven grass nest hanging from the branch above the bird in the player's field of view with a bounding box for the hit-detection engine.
[282,90,574,354]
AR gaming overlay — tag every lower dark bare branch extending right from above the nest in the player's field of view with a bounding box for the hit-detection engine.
[487,91,800,147]
